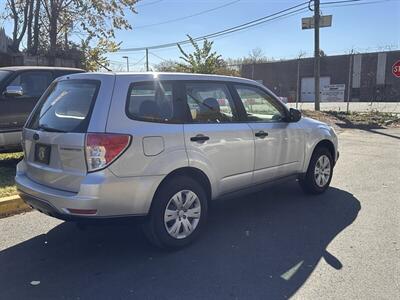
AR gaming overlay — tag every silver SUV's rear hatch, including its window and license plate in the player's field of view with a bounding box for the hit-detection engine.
[22,74,114,192]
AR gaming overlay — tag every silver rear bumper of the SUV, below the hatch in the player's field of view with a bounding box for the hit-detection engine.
[15,161,163,220]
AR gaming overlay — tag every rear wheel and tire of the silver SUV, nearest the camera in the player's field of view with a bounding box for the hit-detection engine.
[143,176,207,249]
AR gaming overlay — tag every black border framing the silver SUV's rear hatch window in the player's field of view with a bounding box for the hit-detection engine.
[24,79,101,133]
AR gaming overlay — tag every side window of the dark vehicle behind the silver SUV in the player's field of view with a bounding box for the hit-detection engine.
[8,71,53,98]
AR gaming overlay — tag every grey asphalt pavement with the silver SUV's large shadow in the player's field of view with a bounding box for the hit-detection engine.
[0,129,400,299]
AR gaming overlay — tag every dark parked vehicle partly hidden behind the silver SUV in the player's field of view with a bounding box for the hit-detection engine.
[0,67,84,152]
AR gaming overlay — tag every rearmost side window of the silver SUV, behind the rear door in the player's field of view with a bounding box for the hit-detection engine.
[126,81,176,123]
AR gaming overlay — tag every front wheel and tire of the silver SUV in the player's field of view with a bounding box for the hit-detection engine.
[299,147,334,195]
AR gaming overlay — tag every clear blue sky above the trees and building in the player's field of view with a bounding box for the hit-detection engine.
[0,0,400,70]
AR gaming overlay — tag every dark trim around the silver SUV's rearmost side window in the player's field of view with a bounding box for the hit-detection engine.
[125,80,185,124]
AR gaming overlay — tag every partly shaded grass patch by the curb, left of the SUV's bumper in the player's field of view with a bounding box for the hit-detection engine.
[0,152,23,198]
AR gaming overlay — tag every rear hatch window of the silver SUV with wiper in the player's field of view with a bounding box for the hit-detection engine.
[27,80,100,132]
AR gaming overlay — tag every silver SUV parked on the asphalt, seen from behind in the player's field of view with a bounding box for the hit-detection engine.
[16,73,338,248]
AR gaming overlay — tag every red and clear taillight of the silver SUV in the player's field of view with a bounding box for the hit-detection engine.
[85,133,131,172]
